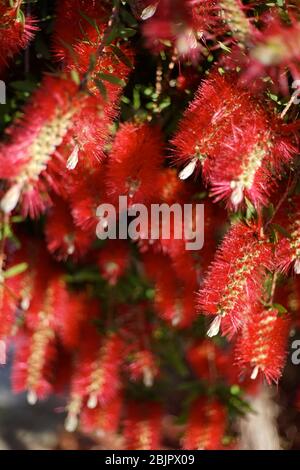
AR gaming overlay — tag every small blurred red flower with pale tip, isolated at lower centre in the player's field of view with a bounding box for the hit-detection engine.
[128,349,159,387]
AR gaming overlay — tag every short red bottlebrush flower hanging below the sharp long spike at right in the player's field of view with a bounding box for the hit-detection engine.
[236,309,290,383]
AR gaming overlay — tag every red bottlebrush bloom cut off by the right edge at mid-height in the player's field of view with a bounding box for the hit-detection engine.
[275,196,300,274]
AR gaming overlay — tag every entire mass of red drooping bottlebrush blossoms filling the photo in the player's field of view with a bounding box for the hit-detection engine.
[0,0,300,450]
